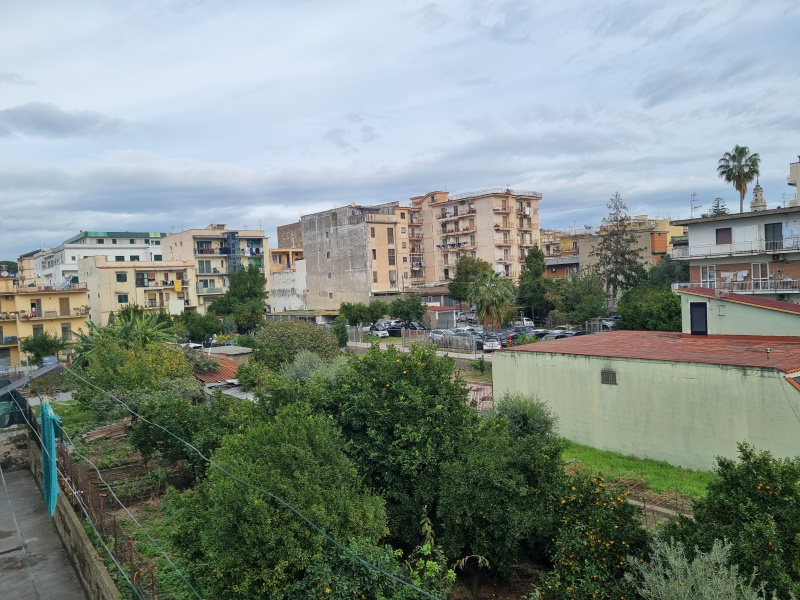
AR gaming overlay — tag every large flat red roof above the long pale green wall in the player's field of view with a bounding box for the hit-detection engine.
[503,331,800,373]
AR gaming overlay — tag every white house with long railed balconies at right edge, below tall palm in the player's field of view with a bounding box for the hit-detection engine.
[672,162,800,302]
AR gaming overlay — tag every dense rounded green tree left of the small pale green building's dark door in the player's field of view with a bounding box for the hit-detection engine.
[617,283,681,331]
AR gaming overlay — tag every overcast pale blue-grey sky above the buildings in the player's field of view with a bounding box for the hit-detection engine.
[0,0,800,260]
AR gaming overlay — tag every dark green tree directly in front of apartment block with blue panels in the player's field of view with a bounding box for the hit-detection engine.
[208,265,267,330]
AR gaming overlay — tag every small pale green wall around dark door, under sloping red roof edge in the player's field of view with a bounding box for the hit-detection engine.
[680,294,800,336]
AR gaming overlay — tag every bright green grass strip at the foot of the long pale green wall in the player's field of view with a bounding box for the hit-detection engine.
[563,442,717,499]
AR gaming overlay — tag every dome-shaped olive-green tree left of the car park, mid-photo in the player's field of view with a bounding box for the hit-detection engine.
[251,319,339,370]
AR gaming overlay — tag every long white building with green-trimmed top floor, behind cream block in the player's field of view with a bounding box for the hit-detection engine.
[27,231,167,286]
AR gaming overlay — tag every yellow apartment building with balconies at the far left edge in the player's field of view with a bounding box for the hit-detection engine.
[0,277,87,366]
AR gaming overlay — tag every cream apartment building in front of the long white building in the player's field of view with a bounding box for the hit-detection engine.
[78,256,197,325]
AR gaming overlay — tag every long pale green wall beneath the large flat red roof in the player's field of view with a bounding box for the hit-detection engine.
[492,350,800,469]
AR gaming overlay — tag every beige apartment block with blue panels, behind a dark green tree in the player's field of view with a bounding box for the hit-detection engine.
[161,224,269,313]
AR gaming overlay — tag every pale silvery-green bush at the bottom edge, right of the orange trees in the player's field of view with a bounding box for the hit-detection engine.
[625,538,776,600]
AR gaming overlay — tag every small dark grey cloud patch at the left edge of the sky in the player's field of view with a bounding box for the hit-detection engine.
[0,102,124,139]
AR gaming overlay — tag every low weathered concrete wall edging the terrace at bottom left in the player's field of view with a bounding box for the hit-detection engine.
[30,434,121,600]
